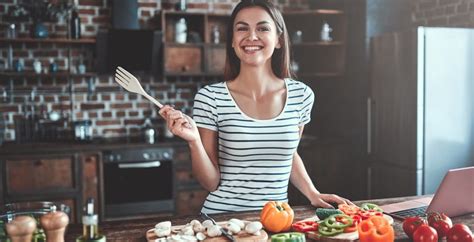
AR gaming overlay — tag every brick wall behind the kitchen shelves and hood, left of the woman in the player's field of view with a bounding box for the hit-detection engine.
[0,0,307,141]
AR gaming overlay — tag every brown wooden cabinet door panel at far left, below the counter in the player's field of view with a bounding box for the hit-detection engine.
[5,156,78,195]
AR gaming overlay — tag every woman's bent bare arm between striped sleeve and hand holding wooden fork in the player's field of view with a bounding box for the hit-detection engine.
[188,128,221,192]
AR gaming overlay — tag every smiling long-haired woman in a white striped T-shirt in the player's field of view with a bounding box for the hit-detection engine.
[160,0,350,213]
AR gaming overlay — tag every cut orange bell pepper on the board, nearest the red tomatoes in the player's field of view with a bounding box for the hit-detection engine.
[357,216,395,242]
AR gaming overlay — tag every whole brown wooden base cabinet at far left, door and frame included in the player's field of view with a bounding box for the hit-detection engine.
[0,154,82,222]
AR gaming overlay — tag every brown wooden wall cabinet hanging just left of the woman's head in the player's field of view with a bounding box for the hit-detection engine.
[160,11,229,77]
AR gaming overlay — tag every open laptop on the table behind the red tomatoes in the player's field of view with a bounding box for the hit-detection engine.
[380,166,474,219]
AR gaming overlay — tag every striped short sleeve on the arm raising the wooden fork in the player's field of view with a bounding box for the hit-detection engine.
[193,86,217,131]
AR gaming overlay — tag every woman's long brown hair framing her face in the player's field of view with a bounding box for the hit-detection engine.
[224,0,292,81]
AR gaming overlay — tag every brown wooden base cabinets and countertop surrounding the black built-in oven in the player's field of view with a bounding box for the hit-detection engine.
[0,141,208,223]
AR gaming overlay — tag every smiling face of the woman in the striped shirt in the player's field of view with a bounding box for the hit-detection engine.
[232,7,280,68]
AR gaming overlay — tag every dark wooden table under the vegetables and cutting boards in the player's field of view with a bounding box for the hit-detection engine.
[66,197,474,242]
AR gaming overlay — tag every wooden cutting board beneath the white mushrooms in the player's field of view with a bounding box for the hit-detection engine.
[146,221,268,242]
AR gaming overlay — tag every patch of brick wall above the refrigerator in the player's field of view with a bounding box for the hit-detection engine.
[413,0,474,28]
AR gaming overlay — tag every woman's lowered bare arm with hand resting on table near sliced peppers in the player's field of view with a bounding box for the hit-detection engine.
[290,126,352,208]
